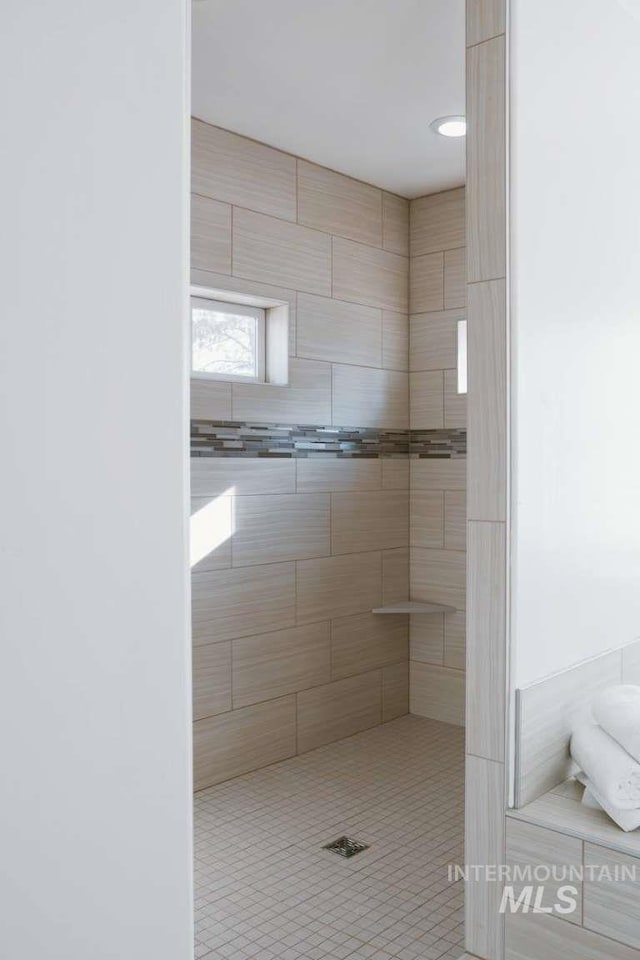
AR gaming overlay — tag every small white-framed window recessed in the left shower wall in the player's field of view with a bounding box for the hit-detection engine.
[191,297,266,383]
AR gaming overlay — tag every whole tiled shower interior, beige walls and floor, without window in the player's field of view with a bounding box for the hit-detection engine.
[191,121,466,960]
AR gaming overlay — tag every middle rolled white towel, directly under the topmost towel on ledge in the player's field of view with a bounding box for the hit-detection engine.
[571,721,640,810]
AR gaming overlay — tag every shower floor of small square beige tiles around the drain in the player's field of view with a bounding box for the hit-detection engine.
[195,716,464,960]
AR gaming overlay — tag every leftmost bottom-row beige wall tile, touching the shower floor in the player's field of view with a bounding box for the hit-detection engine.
[193,696,296,790]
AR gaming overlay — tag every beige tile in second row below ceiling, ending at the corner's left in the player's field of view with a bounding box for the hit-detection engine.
[333,237,409,313]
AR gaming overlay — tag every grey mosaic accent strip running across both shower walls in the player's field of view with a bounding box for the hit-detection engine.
[191,420,467,459]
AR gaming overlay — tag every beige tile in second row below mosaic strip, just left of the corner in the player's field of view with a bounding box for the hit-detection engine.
[331,490,409,554]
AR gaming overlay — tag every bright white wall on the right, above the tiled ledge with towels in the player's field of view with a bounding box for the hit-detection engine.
[511,0,640,686]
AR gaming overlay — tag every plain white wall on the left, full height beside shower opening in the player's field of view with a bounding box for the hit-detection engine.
[0,0,191,960]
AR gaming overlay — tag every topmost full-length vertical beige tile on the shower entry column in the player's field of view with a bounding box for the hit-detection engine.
[467,37,507,283]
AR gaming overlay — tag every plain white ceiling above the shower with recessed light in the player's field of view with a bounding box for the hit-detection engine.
[192,0,465,197]
